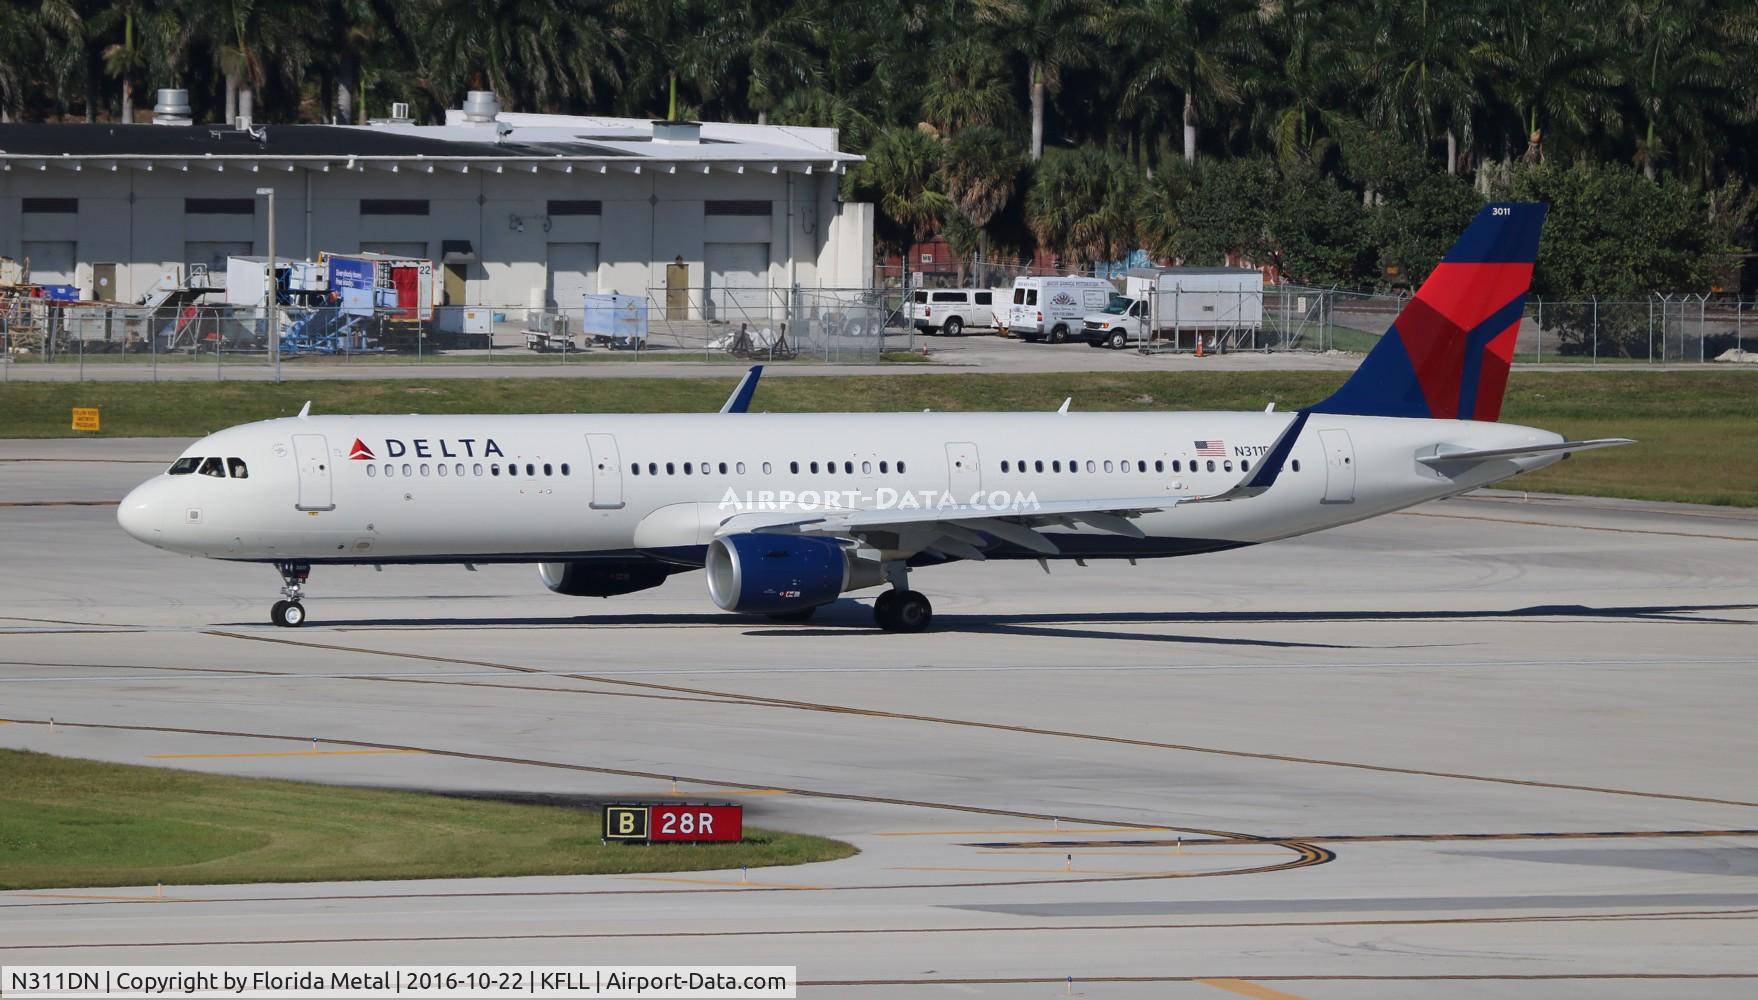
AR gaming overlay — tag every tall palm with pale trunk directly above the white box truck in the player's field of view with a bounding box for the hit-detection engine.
[1106,0,1257,160]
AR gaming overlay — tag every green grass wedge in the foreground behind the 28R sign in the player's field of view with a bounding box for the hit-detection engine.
[0,749,854,889]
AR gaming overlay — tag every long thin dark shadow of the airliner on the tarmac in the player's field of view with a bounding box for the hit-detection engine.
[263,599,1758,649]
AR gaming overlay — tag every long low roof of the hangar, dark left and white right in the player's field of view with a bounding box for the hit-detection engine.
[0,111,861,174]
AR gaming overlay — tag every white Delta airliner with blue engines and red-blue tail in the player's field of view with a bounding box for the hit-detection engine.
[116,204,1630,631]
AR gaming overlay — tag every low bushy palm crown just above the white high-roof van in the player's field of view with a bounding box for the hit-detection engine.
[1025,146,1141,265]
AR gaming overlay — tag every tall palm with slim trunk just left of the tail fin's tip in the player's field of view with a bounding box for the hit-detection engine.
[1366,0,1494,174]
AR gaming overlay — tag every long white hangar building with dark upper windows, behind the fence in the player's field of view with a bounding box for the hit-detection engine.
[0,90,874,318]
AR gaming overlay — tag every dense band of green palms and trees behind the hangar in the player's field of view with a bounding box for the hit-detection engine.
[0,0,1758,293]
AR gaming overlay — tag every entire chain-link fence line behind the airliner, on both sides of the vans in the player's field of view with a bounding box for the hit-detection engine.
[0,283,1758,378]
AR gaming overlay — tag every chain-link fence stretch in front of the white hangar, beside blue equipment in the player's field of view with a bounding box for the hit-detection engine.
[0,288,893,378]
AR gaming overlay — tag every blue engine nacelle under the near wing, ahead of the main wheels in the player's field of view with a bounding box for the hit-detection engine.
[707,533,883,615]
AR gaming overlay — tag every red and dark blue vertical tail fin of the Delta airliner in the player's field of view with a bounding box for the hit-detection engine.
[1311,204,1545,420]
